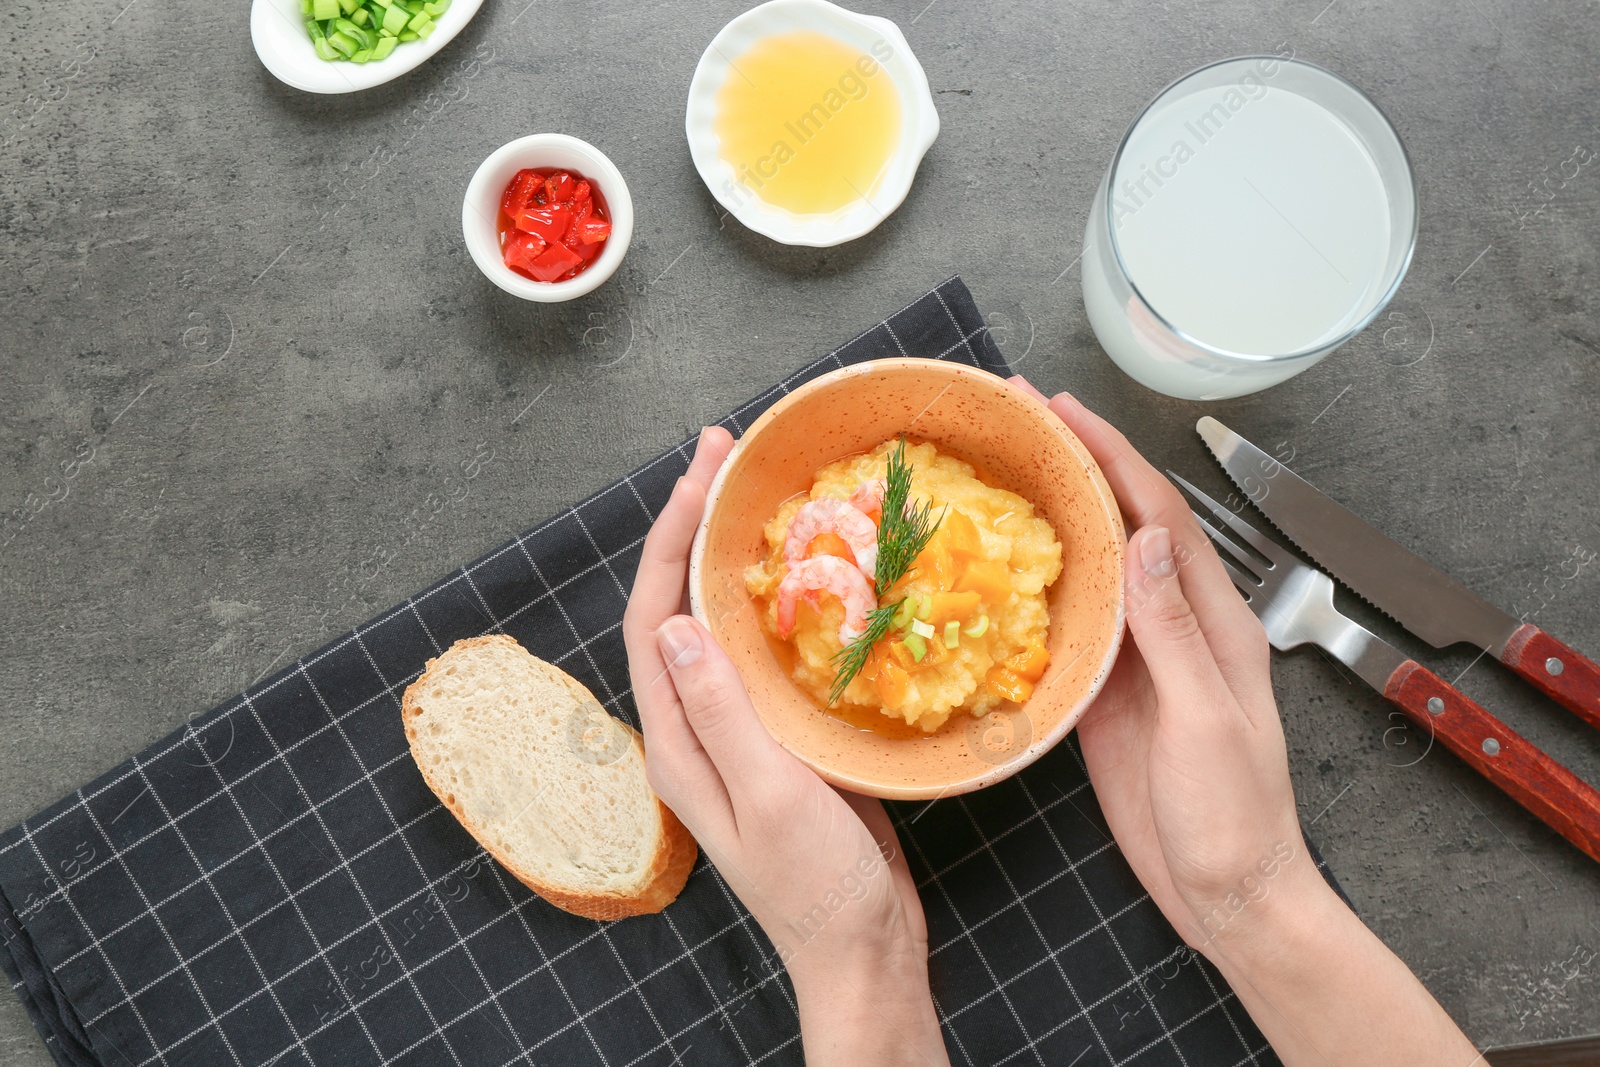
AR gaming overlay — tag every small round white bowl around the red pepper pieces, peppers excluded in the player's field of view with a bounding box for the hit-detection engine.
[460,132,634,304]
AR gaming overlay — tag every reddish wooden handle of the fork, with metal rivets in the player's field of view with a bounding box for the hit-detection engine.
[1384,659,1600,861]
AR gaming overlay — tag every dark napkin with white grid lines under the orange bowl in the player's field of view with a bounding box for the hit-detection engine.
[0,278,1324,1067]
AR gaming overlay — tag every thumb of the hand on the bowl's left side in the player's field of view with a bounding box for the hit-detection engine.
[656,614,794,806]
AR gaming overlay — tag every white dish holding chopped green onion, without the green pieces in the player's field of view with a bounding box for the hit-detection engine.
[250,0,483,93]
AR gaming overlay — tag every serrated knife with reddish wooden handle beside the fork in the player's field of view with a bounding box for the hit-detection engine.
[1195,416,1600,728]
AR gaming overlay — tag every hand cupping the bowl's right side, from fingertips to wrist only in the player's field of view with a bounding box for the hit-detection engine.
[1013,378,1320,952]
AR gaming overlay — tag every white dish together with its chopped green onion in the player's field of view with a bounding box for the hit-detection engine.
[250,0,483,93]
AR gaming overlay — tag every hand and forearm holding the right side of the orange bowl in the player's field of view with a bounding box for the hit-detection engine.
[1011,378,1482,1067]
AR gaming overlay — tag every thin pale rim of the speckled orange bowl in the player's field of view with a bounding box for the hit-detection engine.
[688,357,1128,800]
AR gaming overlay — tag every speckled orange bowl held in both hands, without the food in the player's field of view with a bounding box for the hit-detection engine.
[690,358,1125,800]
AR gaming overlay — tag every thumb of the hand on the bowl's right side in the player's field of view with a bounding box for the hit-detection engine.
[1126,526,1230,709]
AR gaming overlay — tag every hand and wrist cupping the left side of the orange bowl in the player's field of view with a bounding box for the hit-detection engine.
[622,429,949,1065]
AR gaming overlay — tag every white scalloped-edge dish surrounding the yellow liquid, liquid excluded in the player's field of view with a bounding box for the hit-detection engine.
[685,0,939,248]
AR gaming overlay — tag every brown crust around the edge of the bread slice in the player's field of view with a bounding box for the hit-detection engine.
[400,633,699,920]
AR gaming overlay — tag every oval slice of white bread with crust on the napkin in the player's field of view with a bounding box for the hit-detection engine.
[400,635,698,918]
